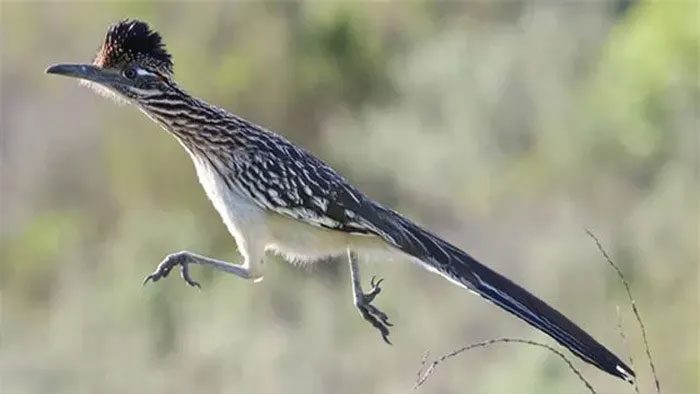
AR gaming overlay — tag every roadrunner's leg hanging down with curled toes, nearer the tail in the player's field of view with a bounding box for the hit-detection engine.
[348,250,392,345]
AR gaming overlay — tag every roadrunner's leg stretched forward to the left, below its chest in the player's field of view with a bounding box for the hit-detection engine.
[143,251,262,287]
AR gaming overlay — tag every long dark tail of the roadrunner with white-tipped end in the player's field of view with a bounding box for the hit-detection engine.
[374,209,635,382]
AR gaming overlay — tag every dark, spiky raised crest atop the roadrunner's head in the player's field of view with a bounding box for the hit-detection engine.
[94,19,173,73]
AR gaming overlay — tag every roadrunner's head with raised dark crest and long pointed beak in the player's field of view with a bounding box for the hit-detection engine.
[46,20,173,103]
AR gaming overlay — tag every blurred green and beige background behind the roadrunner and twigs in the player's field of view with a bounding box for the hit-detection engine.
[0,0,700,393]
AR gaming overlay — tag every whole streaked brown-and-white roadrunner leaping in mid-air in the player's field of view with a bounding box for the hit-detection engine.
[46,20,634,381]
